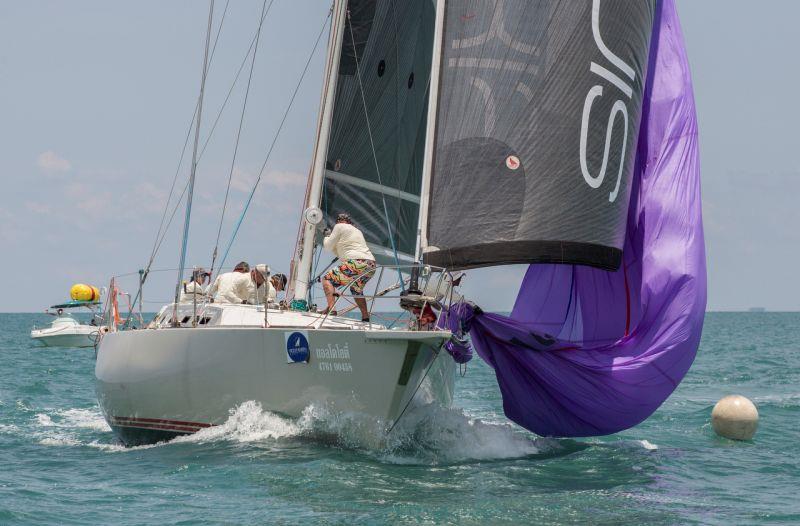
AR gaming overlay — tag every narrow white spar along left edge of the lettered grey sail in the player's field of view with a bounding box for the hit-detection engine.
[416,0,445,262]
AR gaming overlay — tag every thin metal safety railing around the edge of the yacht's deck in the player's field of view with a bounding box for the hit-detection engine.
[103,265,460,331]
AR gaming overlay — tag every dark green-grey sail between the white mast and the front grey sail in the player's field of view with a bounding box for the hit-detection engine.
[321,0,435,263]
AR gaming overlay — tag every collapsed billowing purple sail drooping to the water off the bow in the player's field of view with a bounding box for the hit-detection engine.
[446,0,706,437]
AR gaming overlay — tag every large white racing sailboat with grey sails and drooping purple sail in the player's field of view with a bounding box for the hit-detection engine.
[95,0,705,444]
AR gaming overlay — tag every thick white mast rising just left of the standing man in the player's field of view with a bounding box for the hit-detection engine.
[289,0,347,308]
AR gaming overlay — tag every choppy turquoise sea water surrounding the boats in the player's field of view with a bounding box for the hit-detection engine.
[0,313,800,525]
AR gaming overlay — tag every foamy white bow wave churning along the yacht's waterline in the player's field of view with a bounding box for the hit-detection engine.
[25,401,570,464]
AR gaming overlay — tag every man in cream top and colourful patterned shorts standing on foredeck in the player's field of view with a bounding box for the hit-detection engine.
[321,212,375,321]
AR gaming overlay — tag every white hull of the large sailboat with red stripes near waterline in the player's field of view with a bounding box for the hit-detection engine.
[95,314,455,444]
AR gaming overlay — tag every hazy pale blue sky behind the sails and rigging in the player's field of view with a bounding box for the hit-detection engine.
[0,0,800,312]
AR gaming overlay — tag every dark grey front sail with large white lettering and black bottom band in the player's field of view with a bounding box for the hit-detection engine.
[425,0,655,269]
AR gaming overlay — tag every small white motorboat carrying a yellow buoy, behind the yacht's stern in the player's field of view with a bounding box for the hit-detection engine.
[31,284,100,347]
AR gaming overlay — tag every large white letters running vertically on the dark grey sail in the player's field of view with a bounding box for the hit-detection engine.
[580,0,636,203]
